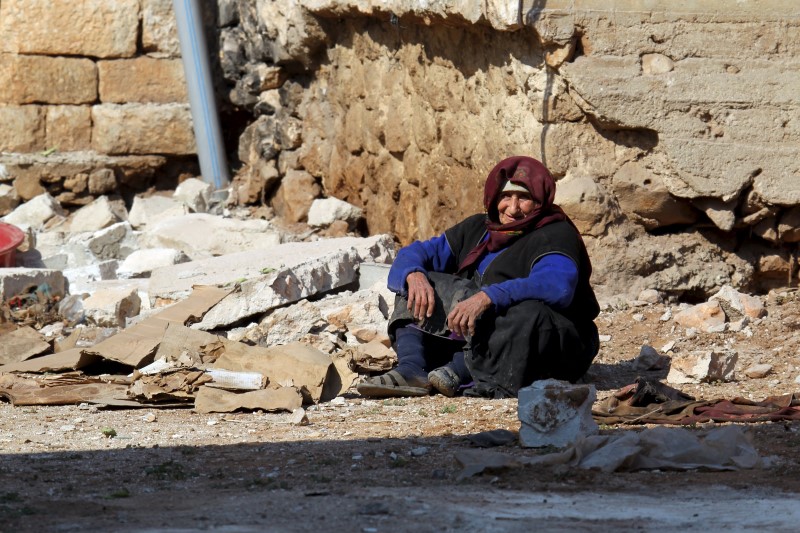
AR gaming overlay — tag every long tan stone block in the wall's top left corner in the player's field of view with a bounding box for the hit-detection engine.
[0,0,139,57]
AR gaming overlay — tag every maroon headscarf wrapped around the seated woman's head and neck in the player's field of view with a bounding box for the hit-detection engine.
[458,156,574,271]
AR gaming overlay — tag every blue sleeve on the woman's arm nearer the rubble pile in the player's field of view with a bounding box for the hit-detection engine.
[387,235,456,296]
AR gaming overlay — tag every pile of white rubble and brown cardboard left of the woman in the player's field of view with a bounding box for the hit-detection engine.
[0,179,394,417]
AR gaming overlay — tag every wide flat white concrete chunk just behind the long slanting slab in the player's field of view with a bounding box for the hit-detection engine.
[141,213,282,260]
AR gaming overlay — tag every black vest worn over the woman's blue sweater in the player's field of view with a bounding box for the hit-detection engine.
[445,214,600,323]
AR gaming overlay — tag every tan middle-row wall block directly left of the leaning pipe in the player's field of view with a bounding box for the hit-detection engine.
[97,57,188,104]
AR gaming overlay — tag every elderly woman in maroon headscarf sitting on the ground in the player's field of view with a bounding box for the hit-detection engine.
[357,157,599,398]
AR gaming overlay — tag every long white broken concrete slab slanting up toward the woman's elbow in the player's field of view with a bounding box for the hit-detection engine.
[149,235,394,330]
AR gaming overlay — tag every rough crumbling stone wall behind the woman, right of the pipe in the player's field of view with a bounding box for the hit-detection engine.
[220,0,800,298]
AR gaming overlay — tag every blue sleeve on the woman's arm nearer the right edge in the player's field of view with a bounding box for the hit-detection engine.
[482,253,578,311]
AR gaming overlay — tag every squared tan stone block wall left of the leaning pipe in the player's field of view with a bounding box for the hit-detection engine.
[0,0,195,206]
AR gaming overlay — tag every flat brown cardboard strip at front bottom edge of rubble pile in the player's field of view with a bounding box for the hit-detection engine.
[194,386,303,413]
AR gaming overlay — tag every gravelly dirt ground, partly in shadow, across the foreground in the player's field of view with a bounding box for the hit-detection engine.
[0,292,800,532]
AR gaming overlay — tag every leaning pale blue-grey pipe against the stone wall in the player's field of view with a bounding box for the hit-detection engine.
[172,0,229,189]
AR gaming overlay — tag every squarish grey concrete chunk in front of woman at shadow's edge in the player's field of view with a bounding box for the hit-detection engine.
[518,379,600,448]
